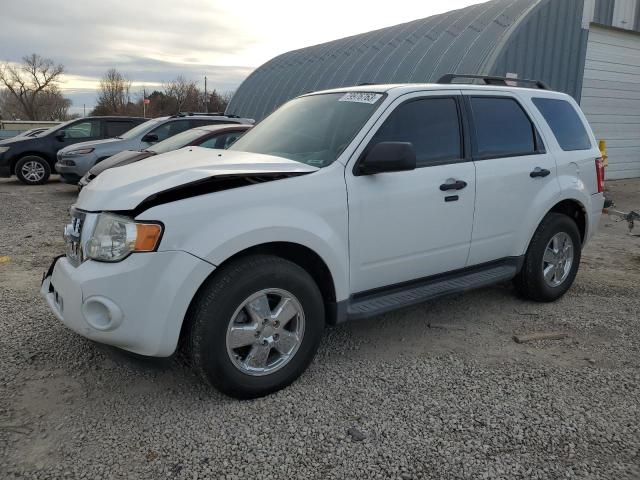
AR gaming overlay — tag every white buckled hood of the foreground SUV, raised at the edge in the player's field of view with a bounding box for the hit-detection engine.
[76,147,318,212]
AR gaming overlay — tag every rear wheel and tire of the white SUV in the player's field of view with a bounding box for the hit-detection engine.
[513,213,582,302]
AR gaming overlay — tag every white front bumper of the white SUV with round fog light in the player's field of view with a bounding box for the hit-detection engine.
[40,251,214,357]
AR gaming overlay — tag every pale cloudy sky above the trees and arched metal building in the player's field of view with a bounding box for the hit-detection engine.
[0,0,482,114]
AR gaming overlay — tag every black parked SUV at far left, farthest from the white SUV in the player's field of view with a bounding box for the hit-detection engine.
[0,117,145,185]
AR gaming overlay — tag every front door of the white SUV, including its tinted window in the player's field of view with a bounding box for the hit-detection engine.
[346,92,475,293]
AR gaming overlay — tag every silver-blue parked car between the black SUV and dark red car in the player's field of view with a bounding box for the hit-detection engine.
[56,114,253,184]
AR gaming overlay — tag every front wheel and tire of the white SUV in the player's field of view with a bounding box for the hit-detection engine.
[185,255,325,398]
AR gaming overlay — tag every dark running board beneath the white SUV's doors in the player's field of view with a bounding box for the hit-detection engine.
[346,258,521,320]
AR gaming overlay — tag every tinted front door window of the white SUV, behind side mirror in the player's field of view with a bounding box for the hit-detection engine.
[369,97,463,167]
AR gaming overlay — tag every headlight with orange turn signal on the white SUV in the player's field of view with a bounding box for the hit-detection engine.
[86,213,162,262]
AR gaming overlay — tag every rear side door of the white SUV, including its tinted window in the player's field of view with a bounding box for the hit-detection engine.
[463,90,560,266]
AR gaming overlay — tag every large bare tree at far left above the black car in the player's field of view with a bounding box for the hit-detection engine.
[0,53,68,120]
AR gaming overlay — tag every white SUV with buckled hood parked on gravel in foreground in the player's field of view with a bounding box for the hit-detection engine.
[42,78,604,398]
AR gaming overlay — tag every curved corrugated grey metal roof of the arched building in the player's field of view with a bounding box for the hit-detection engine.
[227,0,540,120]
